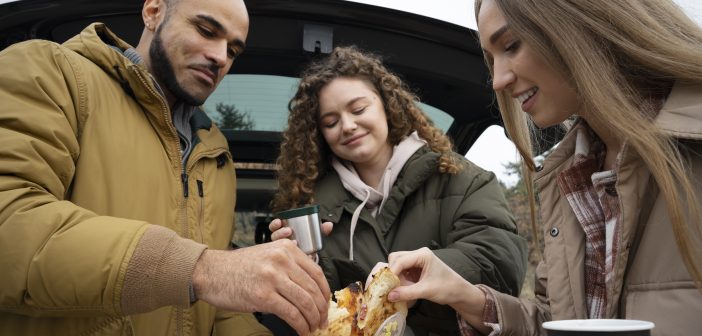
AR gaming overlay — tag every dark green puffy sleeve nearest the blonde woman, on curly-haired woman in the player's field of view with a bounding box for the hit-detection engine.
[410,164,527,332]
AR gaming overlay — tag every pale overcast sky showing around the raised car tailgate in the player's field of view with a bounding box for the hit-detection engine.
[350,0,702,185]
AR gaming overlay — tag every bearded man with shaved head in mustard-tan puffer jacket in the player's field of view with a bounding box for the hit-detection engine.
[0,0,330,335]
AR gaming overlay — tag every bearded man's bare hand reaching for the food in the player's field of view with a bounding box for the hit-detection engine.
[193,239,331,335]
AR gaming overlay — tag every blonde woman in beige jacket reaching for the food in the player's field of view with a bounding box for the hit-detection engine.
[382,0,702,335]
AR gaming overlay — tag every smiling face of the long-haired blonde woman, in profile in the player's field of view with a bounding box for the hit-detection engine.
[478,0,581,127]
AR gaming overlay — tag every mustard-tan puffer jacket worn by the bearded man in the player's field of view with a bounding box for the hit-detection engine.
[0,24,270,335]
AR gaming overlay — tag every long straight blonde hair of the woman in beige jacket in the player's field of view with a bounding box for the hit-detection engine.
[475,0,702,290]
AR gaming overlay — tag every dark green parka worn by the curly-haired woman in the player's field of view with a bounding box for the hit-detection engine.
[315,146,526,335]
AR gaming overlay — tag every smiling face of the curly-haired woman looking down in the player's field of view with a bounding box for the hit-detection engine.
[319,78,392,168]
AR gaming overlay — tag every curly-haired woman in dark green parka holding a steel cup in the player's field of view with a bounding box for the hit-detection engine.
[270,47,526,335]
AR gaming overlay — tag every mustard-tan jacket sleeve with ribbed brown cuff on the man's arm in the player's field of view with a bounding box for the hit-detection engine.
[0,41,205,316]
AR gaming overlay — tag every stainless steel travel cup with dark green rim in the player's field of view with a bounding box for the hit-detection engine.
[276,204,323,254]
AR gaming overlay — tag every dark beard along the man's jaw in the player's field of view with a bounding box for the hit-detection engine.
[149,25,205,106]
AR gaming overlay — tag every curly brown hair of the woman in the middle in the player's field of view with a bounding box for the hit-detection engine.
[272,46,462,211]
